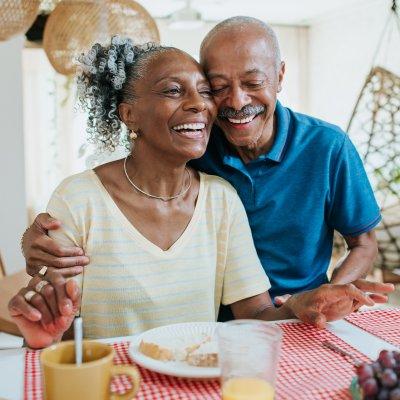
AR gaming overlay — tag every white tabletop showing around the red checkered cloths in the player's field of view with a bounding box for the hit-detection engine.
[0,320,398,400]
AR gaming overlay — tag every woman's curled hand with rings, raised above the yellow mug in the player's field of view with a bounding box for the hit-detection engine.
[8,268,80,348]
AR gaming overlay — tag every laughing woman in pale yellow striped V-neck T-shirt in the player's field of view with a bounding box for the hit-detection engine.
[9,37,391,347]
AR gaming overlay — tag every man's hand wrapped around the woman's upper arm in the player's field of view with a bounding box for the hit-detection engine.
[21,214,89,277]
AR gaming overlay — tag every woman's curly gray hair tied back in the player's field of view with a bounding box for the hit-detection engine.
[77,36,177,151]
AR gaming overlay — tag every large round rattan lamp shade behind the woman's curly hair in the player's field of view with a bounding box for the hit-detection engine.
[43,0,160,75]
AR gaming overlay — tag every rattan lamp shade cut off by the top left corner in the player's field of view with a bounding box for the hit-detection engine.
[0,0,40,41]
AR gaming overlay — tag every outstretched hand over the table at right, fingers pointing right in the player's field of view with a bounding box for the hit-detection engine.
[285,279,394,329]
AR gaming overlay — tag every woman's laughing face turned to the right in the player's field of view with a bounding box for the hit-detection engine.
[128,50,216,162]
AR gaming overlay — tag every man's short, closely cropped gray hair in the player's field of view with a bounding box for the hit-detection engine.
[200,16,281,69]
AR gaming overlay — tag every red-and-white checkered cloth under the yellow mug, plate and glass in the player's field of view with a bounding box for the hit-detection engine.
[24,322,368,400]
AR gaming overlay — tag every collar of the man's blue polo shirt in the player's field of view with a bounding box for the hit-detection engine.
[217,100,290,168]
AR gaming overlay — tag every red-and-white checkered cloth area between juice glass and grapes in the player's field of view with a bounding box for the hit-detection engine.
[276,322,370,400]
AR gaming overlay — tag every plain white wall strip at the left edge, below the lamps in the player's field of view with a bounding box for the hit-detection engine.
[0,36,27,274]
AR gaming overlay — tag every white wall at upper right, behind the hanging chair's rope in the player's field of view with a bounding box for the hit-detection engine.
[308,0,400,129]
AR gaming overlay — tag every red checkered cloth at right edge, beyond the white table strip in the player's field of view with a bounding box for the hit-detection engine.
[346,308,400,347]
